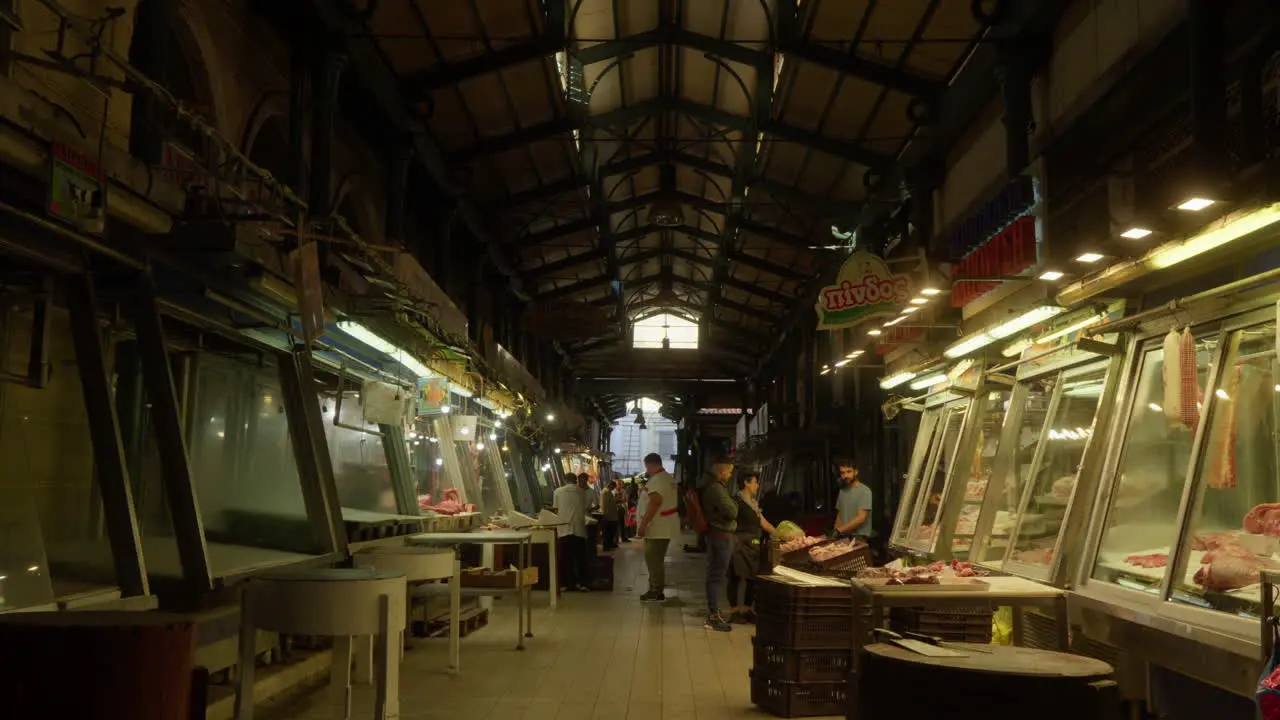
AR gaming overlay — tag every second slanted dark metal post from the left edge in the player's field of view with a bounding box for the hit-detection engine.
[129,285,214,592]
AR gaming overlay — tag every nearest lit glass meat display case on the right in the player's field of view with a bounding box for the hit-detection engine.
[1071,292,1280,696]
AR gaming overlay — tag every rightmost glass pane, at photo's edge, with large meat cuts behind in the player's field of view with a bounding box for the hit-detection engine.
[1170,319,1280,618]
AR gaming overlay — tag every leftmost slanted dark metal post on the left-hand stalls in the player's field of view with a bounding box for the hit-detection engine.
[65,275,151,597]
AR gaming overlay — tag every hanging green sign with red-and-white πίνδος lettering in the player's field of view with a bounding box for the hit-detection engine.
[815,252,911,331]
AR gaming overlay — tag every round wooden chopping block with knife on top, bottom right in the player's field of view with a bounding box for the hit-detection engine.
[851,643,1120,720]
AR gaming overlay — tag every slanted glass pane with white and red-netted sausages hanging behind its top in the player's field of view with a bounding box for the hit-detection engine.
[1091,324,1218,594]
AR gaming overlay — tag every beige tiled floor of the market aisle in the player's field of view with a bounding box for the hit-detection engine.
[269,542,814,720]
